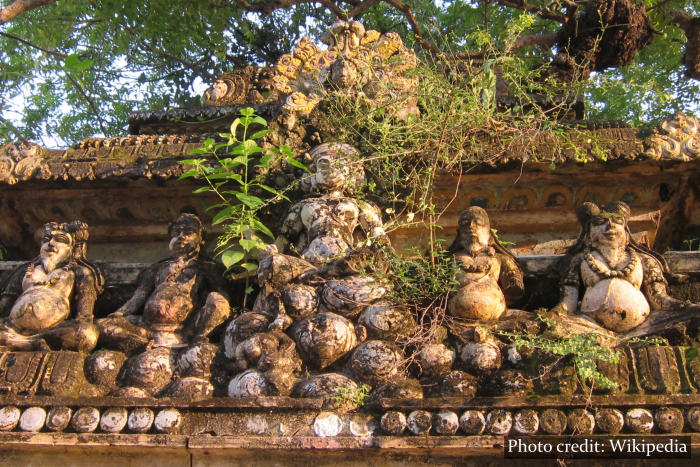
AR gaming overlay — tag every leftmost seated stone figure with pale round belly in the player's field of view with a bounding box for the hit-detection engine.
[0,221,104,352]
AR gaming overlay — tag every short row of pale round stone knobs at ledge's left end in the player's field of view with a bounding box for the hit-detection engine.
[0,406,182,433]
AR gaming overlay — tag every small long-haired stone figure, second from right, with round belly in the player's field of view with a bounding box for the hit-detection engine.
[448,206,523,321]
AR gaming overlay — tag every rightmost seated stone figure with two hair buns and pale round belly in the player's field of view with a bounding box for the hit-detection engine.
[553,201,700,336]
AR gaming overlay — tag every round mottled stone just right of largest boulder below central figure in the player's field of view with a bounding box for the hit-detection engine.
[350,340,403,386]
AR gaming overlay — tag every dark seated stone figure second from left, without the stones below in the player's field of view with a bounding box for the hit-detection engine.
[97,214,230,353]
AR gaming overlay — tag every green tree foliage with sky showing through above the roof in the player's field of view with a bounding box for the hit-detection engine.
[0,0,700,144]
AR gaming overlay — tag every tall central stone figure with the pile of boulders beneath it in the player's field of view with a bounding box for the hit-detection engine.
[224,143,402,397]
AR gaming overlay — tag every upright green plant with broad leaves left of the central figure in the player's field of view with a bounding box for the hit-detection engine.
[180,108,306,294]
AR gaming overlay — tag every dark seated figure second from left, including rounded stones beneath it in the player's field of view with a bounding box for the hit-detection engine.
[97,214,231,397]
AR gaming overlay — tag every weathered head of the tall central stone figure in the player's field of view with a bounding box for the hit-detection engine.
[302,143,364,195]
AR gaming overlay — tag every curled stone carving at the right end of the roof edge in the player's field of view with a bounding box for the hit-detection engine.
[644,113,700,162]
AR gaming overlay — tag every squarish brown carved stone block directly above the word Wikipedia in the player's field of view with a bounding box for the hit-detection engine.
[634,346,681,394]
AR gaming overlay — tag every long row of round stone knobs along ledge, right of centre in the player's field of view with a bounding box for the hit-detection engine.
[381,407,700,436]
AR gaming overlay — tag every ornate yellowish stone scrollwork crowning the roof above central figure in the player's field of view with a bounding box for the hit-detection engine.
[203,20,419,128]
